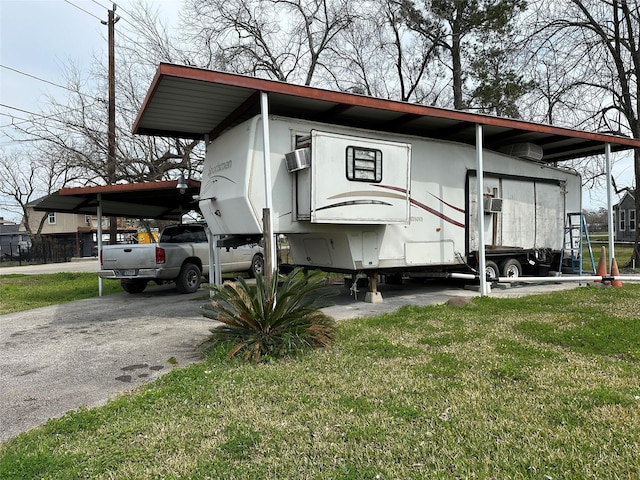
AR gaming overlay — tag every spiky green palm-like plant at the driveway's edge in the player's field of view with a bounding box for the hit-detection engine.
[203,268,335,363]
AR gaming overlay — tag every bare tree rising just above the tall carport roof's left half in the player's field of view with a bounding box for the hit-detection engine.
[184,0,354,85]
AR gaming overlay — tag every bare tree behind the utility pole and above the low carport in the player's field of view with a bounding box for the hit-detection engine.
[8,7,203,191]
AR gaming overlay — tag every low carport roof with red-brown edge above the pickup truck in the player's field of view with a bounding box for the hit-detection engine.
[33,180,200,221]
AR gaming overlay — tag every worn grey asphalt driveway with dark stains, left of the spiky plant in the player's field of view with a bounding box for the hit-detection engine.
[0,285,213,441]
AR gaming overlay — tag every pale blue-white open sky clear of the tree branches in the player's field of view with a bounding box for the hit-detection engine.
[0,0,633,218]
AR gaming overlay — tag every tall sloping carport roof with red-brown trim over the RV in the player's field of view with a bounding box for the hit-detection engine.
[133,63,640,162]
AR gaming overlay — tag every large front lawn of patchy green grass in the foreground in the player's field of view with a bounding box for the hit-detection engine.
[0,284,640,480]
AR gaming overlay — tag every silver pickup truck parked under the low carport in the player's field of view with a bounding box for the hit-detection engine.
[98,224,264,293]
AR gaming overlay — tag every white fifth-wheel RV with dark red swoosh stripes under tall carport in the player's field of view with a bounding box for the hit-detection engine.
[200,115,581,277]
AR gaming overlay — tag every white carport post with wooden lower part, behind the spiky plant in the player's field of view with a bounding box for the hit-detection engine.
[260,92,277,292]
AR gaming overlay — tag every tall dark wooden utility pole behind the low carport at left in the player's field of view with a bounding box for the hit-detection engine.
[102,3,120,245]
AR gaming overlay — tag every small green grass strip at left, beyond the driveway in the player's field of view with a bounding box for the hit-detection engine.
[0,272,122,315]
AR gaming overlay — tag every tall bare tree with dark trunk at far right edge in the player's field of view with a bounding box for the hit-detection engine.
[540,0,640,262]
